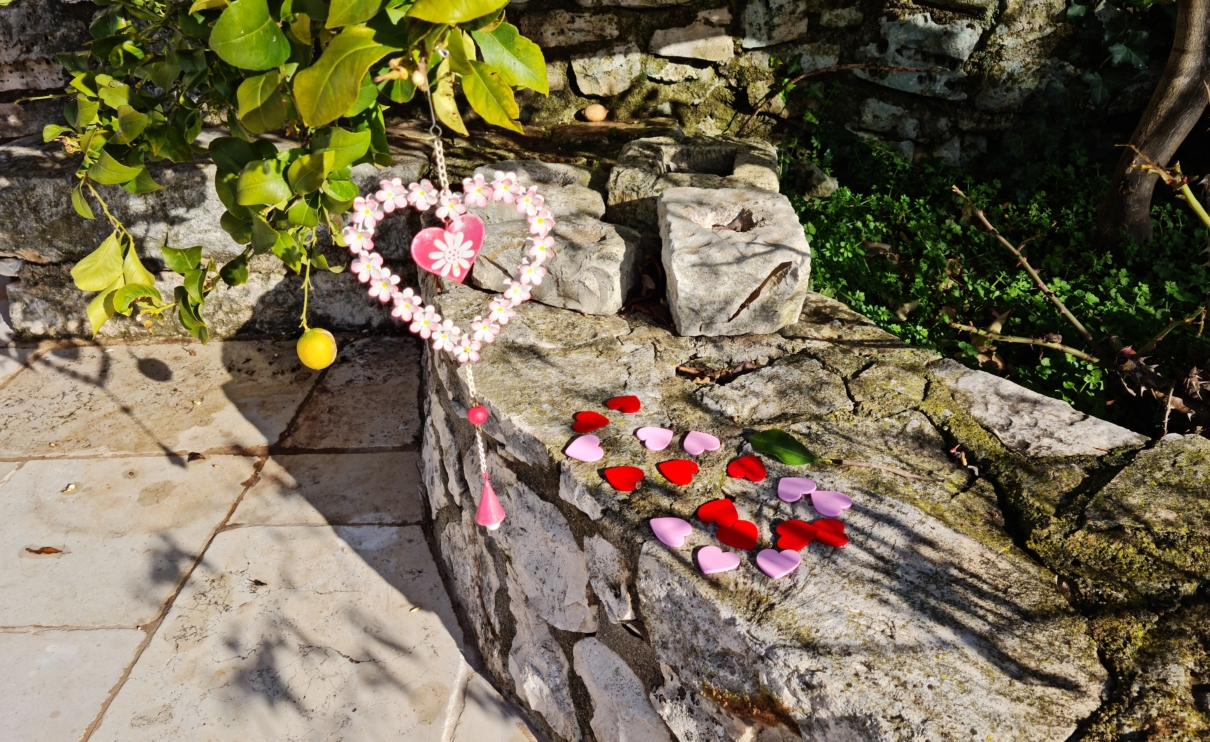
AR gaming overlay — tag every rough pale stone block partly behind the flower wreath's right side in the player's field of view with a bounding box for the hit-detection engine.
[471,215,640,315]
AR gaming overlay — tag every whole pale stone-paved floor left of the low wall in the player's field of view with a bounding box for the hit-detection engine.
[0,338,536,742]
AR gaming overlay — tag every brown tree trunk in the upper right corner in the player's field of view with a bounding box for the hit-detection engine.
[1096,0,1210,249]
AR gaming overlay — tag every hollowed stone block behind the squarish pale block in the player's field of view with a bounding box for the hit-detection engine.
[607,137,778,230]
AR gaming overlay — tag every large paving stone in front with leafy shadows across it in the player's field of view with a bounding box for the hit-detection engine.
[92,525,463,742]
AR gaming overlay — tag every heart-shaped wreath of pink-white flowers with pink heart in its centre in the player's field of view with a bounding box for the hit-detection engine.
[341,171,554,363]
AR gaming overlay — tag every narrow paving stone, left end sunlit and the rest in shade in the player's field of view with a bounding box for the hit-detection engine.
[231,451,424,525]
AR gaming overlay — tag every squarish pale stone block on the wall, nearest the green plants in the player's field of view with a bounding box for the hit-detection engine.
[658,188,811,335]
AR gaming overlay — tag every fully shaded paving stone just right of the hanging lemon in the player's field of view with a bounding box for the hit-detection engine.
[282,338,420,449]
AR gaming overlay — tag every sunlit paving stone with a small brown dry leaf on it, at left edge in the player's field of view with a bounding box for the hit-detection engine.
[0,456,254,627]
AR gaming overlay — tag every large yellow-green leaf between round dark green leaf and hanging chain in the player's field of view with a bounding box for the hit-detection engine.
[291,25,396,126]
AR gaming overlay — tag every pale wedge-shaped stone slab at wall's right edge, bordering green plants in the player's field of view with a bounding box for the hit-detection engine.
[929,361,1147,458]
